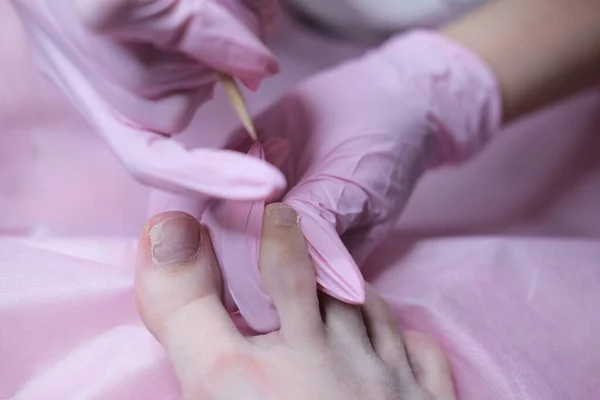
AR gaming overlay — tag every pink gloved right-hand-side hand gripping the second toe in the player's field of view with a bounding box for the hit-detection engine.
[156,32,500,332]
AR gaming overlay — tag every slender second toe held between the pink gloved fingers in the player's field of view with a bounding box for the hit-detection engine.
[260,203,325,341]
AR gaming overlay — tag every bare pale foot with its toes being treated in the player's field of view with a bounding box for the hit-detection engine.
[136,204,455,400]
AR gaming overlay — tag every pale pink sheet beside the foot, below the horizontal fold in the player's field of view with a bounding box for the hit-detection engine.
[0,235,600,400]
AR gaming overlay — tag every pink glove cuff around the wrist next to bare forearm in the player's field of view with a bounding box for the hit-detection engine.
[378,31,502,166]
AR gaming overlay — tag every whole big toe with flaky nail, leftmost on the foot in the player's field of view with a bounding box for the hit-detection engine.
[135,212,245,380]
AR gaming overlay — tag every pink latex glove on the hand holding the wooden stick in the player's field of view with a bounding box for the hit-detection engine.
[12,0,285,200]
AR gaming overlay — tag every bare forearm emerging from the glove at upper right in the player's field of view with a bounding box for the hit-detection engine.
[442,0,600,122]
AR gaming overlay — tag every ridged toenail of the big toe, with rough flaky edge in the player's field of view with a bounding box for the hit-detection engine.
[150,215,202,266]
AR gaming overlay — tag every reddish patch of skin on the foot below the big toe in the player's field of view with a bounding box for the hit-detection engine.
[208,353,275,399]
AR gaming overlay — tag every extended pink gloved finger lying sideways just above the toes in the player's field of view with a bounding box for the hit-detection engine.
[110,132,285,201]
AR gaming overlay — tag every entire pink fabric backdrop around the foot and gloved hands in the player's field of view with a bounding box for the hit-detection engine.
[0,2,600,400]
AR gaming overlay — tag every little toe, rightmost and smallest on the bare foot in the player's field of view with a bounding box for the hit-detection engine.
[404,331,456,400]
